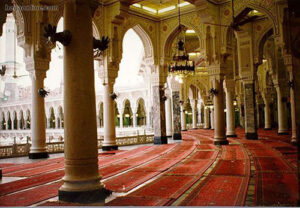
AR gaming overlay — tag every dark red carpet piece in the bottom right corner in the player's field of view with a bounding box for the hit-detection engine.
[255,172,298,206]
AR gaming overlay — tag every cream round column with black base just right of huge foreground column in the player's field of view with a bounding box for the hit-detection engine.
[102,82,118,151]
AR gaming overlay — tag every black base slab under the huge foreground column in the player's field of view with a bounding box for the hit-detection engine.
[58,188,112,204]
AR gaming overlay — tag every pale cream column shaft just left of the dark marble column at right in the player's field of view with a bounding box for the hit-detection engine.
[225,80,236,137]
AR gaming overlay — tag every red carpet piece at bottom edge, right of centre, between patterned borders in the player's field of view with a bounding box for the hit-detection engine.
[180,176,248,206]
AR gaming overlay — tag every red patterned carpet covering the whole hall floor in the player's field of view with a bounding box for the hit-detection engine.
[0,129,298,206]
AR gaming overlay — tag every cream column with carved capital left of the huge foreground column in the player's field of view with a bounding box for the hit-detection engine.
[25,61,49,159]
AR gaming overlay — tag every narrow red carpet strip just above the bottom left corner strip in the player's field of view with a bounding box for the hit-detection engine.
[0,170,65,196]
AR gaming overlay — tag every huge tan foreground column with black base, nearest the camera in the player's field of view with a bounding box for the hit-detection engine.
[58,0,108,203]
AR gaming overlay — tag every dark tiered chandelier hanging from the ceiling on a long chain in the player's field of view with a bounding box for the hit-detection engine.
[169,0,195,75]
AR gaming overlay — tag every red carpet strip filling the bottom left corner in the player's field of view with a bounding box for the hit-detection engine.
[0,182,62,206]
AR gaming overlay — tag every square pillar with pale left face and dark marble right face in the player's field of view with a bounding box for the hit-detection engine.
[152,84,168,144]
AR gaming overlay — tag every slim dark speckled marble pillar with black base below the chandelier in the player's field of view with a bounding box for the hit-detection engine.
[172,91,182,140]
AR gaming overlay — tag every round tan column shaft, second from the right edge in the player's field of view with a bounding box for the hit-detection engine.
[275,85,289,134]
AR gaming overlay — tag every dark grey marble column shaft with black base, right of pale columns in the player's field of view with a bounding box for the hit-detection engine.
[244,80,258,140]
